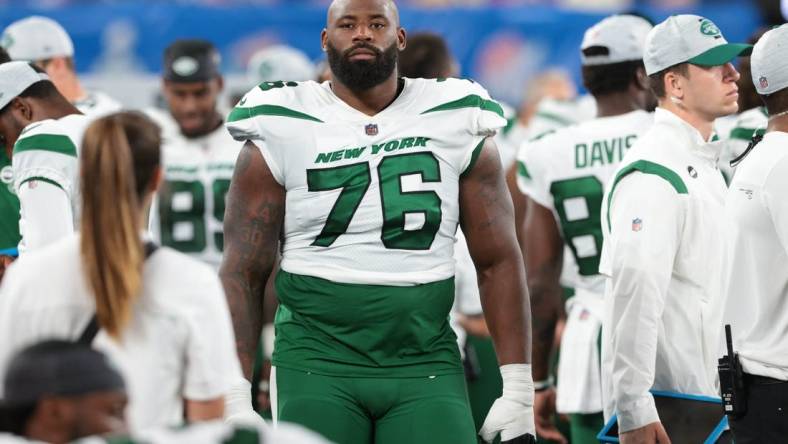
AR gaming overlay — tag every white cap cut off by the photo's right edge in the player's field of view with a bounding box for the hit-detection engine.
[750,25,788,95]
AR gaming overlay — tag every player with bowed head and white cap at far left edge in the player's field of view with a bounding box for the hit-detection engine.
[0,62,90,253]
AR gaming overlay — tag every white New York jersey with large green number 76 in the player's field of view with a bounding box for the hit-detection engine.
[227,78,506,286]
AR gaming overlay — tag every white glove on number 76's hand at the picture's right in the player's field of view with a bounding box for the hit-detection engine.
[479,364,536,442]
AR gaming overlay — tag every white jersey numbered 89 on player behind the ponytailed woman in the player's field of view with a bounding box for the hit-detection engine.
[148,112,243,269]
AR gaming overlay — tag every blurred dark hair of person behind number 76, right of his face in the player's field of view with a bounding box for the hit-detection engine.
[398,33,452,79]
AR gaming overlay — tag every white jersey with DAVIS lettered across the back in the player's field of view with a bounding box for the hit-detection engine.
[517,111,653,295]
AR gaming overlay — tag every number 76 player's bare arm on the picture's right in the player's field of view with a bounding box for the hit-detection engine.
[460,139,531,365]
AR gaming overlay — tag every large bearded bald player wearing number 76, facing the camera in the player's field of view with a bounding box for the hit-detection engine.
[220,0,534,444]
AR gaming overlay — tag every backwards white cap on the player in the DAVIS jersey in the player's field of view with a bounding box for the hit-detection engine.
[580,15,653,66]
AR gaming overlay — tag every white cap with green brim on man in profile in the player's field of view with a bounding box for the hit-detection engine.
[643,14,752,75]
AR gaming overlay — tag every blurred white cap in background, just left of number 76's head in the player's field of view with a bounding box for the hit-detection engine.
[246,45,315,84]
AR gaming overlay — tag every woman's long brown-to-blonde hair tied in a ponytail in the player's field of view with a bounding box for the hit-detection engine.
[80,112,160,338]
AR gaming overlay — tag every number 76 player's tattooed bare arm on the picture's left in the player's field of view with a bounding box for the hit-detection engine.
[219,141,285,380]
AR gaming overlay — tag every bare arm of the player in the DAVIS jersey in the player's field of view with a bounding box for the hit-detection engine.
[520,199,564,381]
